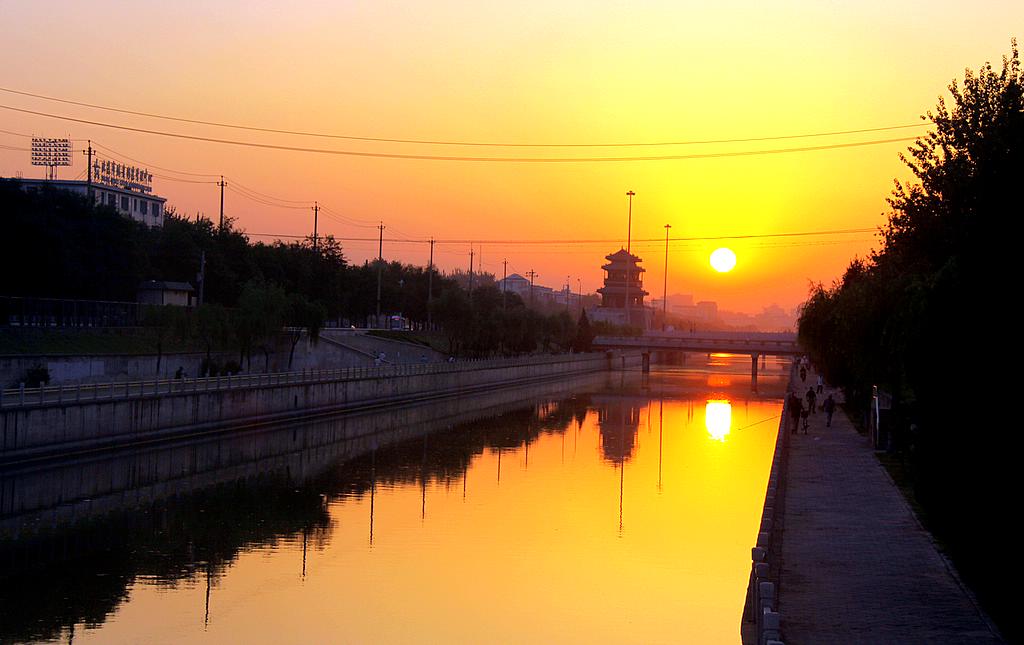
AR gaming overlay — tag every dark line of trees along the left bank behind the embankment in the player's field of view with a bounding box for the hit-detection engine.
[0,180,592,370]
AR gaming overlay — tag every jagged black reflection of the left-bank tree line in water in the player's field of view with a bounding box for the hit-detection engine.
[0,396,589,642]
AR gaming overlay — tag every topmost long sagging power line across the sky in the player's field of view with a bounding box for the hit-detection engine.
[0,87,926,147]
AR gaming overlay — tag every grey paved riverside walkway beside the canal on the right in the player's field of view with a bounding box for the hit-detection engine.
[778,375,1002,645]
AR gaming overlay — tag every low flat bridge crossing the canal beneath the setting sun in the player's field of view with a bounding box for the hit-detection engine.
[594,332,803,391]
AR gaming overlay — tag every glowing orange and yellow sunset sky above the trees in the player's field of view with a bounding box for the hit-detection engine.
[0,1,1024,311]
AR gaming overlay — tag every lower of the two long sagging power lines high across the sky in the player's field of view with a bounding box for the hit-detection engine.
[0,104,918,164]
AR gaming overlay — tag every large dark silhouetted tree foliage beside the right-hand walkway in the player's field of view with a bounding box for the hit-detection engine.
[800,41,1024,636]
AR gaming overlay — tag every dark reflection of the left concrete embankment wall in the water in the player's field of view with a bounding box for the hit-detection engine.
[0,373,610,544]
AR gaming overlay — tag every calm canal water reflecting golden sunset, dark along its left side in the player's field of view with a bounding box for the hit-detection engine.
[0,355,785,643]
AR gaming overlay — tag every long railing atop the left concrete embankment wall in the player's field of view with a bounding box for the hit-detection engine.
[0,353,605,410]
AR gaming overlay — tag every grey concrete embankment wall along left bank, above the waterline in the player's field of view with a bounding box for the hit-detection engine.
[0,354,618,463]
